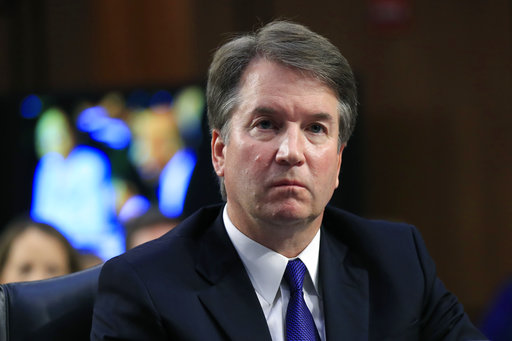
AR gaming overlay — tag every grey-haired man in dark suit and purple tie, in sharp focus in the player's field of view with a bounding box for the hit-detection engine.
[92,21,484,341]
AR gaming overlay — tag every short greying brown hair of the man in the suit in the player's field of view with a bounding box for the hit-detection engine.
[206,20,357,199]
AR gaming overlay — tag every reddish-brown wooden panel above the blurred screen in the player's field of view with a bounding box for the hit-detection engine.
[91,0,200,86]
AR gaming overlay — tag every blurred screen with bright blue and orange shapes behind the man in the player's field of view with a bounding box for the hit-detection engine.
[6,85,219,259]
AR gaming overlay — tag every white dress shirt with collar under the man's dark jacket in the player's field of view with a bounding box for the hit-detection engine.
[222,206,325,341]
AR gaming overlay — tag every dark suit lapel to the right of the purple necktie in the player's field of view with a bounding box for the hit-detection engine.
[319,226,369,340]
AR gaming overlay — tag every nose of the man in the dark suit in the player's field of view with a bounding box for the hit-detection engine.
[276,128,305,166]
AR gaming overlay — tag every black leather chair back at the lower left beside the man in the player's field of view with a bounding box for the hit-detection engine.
[0,265,102,341]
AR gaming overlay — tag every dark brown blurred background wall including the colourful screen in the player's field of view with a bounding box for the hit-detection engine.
[0,0,512,320]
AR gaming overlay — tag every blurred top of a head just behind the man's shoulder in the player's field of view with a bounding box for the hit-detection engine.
[125,207,179,250]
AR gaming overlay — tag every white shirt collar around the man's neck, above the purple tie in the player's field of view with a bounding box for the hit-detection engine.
[222,206,321,304]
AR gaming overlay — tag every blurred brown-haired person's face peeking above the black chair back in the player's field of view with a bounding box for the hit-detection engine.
[0,217,80,283]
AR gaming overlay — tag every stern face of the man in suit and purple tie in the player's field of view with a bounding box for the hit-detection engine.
[212,59,344,229]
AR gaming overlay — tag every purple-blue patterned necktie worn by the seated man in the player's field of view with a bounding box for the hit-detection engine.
[284,258,320,341]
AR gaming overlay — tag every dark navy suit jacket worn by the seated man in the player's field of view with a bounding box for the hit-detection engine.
[91,206,485,341]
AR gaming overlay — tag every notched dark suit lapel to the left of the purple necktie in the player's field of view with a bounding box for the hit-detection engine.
[196,214,271,341]
